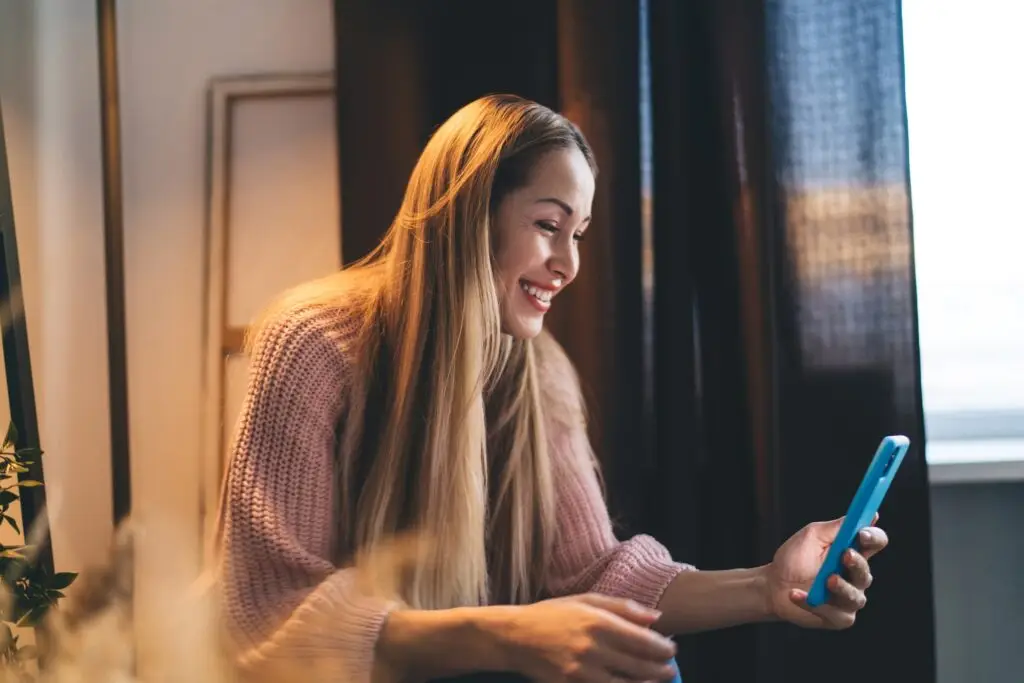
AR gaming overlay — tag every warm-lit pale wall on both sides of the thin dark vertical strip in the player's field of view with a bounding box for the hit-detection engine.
[0,0,334,569]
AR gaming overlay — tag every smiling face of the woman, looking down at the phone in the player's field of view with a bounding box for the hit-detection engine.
[494,147,594,339]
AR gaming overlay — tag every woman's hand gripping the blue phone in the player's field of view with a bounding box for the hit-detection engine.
[767,515,889,629]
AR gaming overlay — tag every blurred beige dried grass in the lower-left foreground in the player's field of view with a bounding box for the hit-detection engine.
[0,523,427,683]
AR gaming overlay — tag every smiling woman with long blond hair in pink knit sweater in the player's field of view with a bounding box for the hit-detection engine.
[218,96,887,681]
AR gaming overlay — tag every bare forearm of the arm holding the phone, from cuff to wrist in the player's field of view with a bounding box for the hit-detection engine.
[654,567,772,635]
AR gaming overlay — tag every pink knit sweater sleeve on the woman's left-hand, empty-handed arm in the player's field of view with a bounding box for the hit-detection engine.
[218,310,389,683]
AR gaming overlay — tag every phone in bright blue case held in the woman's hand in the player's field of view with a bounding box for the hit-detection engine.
[807,434,910,607]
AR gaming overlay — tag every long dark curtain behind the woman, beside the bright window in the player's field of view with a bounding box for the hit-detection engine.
[335,0,935,683]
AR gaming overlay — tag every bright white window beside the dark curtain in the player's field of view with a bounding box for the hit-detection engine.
[903,0,1024,480]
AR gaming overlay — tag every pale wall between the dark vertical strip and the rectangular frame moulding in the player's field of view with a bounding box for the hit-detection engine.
[118,0,334,573]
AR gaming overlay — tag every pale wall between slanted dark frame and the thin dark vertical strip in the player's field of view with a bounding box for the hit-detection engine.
[0,0,111,569]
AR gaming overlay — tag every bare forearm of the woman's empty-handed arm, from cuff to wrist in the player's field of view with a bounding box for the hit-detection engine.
[375,606,514,682]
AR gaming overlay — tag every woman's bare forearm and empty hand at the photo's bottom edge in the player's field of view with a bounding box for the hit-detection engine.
[372,595,676,683]
